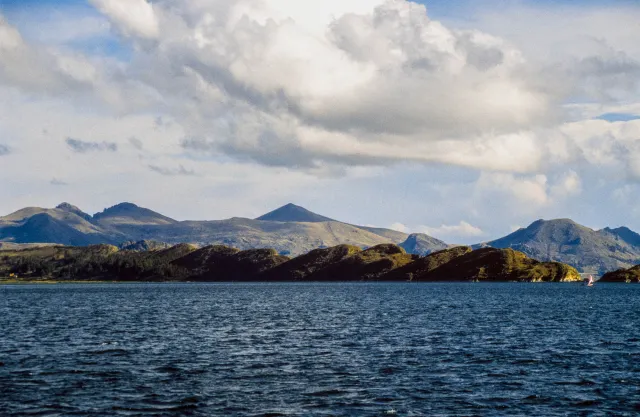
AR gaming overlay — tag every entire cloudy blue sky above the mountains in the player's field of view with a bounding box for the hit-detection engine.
[0,0,640,243]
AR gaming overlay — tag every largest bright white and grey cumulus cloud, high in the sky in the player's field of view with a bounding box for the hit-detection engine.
[84,0,555,172]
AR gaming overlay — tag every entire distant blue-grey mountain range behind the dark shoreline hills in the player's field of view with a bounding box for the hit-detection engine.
[0,203,640,275]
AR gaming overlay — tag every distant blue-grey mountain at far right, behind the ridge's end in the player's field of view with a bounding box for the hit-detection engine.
[474,219,640,275]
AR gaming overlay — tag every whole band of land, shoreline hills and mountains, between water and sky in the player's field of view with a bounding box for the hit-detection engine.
[0,203,640,282]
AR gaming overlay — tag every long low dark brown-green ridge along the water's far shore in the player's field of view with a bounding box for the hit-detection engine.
[0,242,582,282]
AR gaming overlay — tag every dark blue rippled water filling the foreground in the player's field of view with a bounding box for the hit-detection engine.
[0,284,640,416]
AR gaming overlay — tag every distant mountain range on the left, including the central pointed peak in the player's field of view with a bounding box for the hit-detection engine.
[0,203,440,256]
